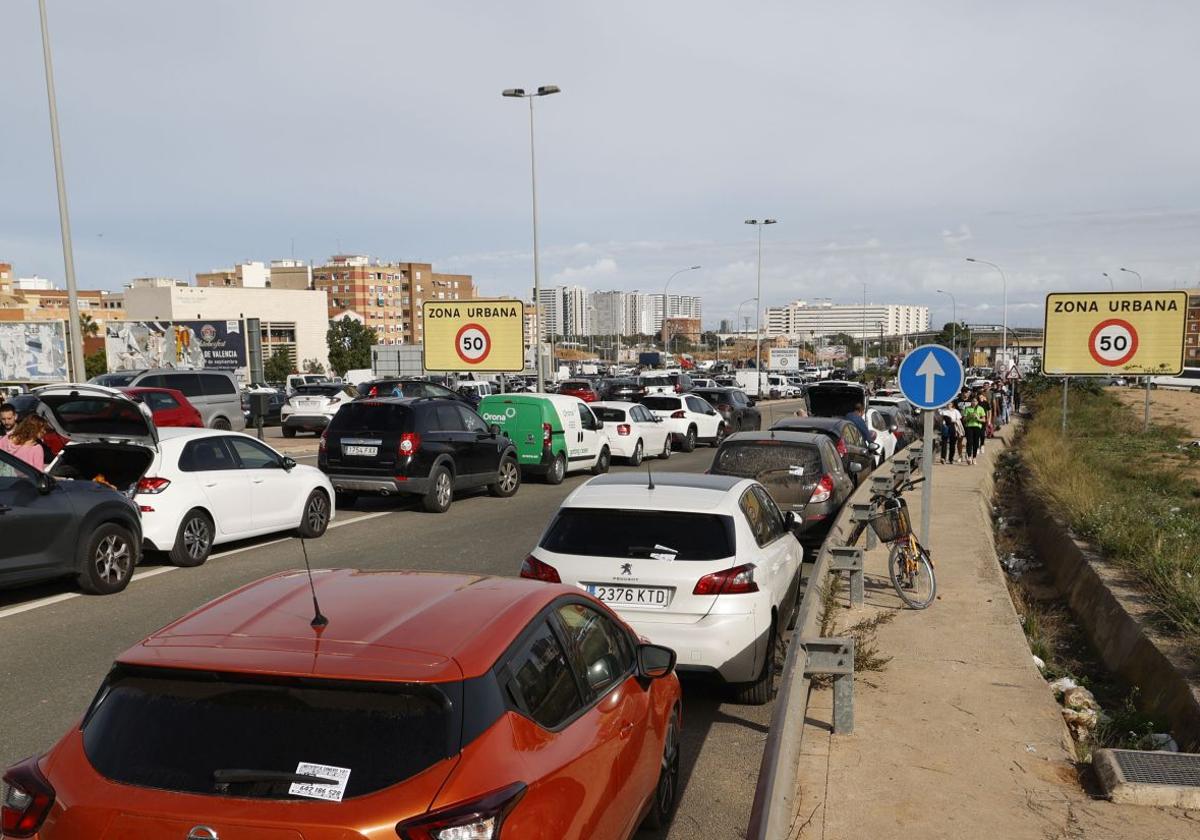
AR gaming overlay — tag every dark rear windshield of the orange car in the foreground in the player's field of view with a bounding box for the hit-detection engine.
[83,668,461,799]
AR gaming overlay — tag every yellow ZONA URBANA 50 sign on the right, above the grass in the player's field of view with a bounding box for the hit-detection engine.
[1042,292,1188,377]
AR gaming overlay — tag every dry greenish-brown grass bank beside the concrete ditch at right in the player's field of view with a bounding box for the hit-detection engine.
[1021,389,1200,643]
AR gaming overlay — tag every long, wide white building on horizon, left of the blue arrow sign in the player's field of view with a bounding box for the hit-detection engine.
[764,300,929,338]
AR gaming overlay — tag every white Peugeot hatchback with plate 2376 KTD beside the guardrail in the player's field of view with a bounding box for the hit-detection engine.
[521,473,804,704]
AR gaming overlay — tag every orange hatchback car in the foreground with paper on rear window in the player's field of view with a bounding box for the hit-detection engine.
[2,570,680,840]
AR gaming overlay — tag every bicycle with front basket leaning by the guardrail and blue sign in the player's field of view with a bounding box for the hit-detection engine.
[846,478,937,610]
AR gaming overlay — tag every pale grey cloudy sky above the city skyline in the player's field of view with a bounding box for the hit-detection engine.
[0,0,1200,325]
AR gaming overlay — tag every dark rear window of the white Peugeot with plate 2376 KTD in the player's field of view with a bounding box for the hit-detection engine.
[541,508,734,560]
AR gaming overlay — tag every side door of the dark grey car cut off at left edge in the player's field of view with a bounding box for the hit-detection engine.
[0,452,79,580]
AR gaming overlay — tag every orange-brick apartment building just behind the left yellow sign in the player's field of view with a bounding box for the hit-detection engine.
[312,254,476,344]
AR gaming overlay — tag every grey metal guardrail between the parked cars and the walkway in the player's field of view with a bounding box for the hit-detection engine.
[746,451,920,840]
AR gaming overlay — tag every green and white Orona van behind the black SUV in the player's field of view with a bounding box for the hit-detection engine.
[479,394,612,484]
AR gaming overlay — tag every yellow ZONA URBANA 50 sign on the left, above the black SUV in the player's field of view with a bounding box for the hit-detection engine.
[421,300,524,373]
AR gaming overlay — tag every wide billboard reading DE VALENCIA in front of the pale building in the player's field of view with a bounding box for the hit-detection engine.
[104,319,247,373]
